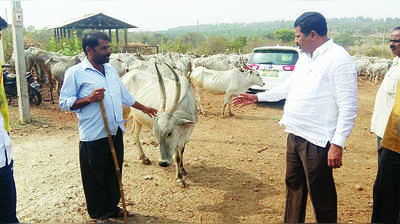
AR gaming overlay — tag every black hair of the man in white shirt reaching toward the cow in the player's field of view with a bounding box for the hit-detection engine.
[294,12,328,36]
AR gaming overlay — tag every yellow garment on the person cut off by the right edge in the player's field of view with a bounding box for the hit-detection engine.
[382,82,400,153]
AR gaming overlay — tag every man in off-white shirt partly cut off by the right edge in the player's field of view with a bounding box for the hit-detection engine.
[371,26,400,163]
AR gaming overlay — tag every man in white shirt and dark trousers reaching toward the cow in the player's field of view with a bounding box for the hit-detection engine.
[234,12,358,223]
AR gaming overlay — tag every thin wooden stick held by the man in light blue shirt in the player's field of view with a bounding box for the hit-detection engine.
[99,100,128,223]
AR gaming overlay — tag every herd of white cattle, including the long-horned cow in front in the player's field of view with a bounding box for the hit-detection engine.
[10,47,390,187]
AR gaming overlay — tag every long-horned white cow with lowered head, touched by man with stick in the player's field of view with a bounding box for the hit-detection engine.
[121,64,198,187]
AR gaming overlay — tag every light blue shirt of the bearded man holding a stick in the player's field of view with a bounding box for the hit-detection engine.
[59,59,136,141]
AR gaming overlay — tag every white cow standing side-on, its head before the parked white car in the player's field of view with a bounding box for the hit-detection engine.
[191,67,264,117]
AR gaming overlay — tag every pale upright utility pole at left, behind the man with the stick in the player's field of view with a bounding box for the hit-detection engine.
[11,0,32,123]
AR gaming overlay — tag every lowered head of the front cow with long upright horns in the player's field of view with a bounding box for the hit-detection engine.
[153,63,193,167]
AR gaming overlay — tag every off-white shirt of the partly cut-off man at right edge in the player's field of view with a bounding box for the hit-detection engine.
[371,57,400,138]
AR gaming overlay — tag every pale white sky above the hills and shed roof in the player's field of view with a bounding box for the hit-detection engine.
[0,0,400,31]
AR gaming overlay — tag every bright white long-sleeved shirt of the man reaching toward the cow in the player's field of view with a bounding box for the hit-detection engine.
[257,40,358,147]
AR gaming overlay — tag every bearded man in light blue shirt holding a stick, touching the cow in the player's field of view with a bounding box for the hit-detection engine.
[59,32,157,223]
